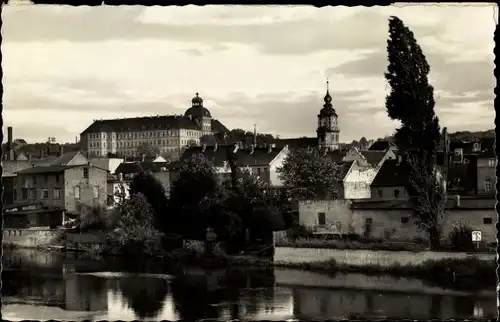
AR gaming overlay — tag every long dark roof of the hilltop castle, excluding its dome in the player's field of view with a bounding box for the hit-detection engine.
[81,115,227,134]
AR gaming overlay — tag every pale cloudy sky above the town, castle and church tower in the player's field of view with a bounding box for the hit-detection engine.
[2,4,497,142]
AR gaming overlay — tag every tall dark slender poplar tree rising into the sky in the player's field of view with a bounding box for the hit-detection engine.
[385,17,445,249]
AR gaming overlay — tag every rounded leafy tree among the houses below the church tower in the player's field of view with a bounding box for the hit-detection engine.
[278,149,342,199]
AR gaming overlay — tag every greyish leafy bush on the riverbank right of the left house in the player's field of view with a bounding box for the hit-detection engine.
[107,193,160,255]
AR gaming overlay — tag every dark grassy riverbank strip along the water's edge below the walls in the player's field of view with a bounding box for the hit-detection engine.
[4,246,496,291]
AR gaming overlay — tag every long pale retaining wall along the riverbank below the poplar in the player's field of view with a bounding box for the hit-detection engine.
[274,247,495,267]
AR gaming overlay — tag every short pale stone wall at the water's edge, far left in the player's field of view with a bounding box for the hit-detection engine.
[3,228,64,247]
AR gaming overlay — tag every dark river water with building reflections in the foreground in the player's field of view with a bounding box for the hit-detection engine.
[2,250,497,321]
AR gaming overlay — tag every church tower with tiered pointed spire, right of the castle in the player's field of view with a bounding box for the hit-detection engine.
[316,81,340,151]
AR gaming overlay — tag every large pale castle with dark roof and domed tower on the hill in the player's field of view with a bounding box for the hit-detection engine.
[80,93,229,159]
